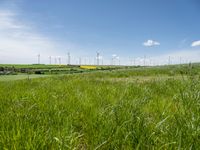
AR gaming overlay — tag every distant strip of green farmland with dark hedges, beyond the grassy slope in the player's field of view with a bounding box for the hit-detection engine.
[0,64,125,76]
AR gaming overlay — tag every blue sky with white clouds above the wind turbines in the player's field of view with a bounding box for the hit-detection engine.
[0,0,200,64]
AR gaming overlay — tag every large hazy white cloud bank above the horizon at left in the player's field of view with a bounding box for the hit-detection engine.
[0,10,68,63]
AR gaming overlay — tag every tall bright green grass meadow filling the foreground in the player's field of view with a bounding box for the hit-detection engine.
[0,65,200,150]
